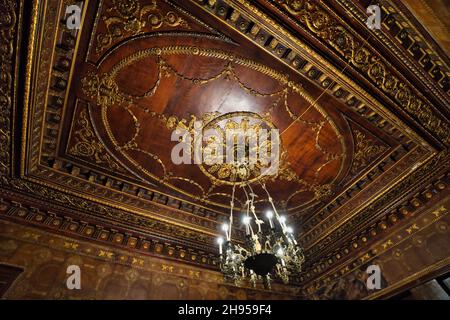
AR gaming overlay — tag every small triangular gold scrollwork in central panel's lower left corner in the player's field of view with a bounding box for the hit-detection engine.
[69,110,122,171]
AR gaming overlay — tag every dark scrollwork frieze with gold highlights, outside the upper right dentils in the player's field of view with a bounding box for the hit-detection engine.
[260,0,450,145]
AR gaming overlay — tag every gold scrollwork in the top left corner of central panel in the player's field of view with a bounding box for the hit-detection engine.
[96,0,190,53]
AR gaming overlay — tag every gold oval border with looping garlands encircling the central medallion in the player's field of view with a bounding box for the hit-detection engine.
[82,46,345,208]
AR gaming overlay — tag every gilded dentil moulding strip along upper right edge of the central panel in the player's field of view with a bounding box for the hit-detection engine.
[193,0,433,150]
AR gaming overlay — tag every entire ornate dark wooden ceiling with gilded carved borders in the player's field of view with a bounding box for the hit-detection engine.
[0,0,450,298]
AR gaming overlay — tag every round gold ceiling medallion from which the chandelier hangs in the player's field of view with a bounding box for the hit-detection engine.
[199,112,280,185]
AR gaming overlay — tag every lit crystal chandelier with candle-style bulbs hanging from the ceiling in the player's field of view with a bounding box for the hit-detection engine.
[218,184,305,289]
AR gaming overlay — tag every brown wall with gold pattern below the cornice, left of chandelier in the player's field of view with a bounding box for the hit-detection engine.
[0,220,299,300]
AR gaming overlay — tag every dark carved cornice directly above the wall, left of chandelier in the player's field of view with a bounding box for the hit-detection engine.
[0,191,221,269]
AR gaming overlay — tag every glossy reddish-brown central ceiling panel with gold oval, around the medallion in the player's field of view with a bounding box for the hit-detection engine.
[34,1,398,218]
